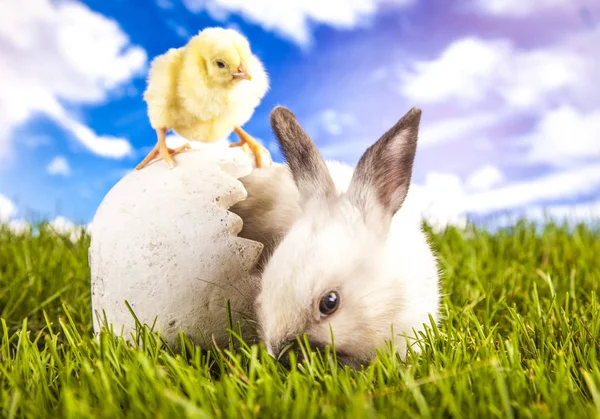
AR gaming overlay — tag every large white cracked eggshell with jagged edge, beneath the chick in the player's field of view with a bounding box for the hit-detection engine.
[89,149,263,347]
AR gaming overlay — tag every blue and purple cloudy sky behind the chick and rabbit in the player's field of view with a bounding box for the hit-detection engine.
[0,0,600,230]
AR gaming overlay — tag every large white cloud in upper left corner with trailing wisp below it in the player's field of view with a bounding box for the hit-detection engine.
[0,0,146,158]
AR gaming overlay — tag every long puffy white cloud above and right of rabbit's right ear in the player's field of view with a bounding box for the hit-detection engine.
[400,37,589,109]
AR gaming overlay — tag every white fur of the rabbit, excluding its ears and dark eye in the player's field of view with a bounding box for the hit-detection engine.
[240,161,440,363]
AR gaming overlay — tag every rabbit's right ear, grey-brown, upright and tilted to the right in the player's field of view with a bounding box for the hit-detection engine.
[348,108,421,220]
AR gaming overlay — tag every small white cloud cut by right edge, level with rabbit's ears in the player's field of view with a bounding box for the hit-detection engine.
[525,105,600,166]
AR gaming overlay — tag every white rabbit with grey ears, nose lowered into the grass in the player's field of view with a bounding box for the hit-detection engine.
[256,107,438,368]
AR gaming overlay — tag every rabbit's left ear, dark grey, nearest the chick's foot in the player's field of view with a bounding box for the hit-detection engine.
[271,106,335,204]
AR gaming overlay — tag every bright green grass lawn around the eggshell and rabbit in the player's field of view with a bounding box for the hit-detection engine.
[0,222,600,419]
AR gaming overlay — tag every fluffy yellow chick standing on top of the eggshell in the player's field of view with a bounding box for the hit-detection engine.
[136,28,271,170]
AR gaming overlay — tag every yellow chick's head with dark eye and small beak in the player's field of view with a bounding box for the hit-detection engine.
[188,28,252,86]
